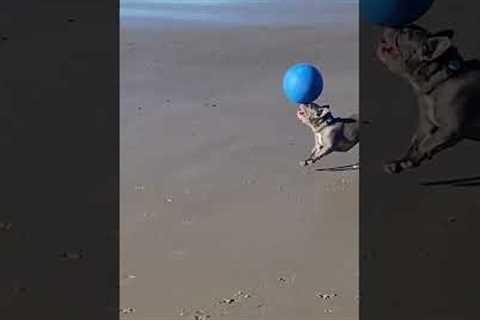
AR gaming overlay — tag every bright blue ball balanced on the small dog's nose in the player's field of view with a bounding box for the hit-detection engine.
[283,63,323,103]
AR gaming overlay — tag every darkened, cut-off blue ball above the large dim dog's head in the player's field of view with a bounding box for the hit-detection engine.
[360,0,434,27]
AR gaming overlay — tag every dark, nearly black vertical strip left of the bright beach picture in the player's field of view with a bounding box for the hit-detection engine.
[0,0,119,320]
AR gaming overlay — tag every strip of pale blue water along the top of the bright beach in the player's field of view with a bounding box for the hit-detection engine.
[120,0,359,25]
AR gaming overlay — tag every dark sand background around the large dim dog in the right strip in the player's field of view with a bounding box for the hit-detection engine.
[360,0,480,320]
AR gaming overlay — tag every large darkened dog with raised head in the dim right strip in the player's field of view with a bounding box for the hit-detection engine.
[377,25,480,173]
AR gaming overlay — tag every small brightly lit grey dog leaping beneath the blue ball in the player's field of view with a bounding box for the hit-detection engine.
[297,103,360,166]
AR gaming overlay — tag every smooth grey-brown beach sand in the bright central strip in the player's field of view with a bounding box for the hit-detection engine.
[120,19,358,320]
